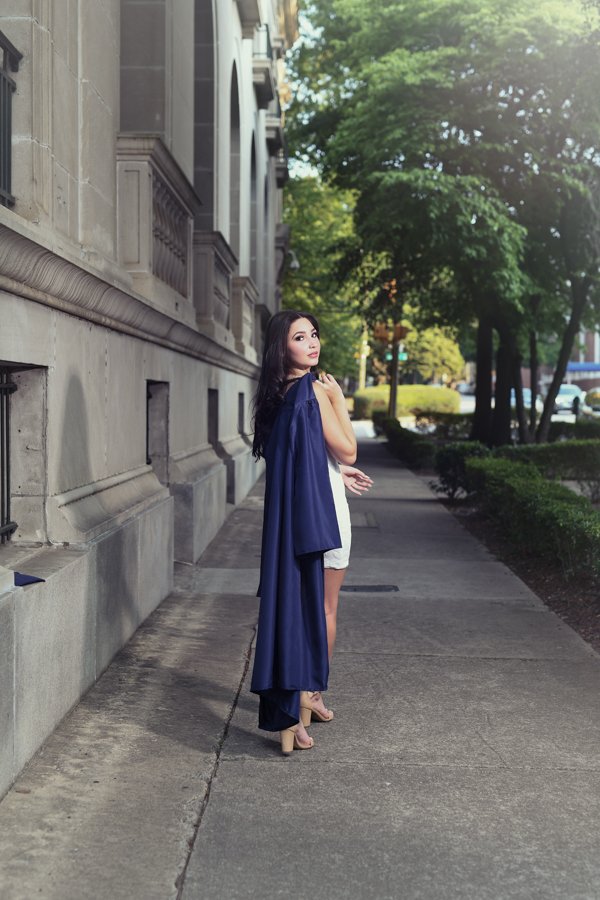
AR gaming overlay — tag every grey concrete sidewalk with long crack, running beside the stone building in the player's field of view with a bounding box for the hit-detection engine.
[0,441,600,900]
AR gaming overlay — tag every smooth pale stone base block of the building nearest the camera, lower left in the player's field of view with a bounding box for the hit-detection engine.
[0,496,173,796]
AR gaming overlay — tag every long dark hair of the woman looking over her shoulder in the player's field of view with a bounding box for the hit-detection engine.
[252,309,319,459]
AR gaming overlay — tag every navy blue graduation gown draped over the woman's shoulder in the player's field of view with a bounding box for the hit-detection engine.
[251,373,341,731]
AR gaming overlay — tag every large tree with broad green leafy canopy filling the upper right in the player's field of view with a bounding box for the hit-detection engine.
[291,0,600,443]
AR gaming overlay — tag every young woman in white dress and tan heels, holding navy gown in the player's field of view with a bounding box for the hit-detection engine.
[251,310,371,753]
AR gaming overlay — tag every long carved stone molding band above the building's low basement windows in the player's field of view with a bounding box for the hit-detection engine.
[0,229,258,378]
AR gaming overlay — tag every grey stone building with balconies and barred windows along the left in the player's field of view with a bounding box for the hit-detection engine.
[0,0,297,793]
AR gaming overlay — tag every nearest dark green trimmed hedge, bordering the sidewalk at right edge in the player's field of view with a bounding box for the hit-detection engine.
[466,458,600,580]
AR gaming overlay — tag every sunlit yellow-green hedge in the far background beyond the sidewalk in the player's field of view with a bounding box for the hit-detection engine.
[354,384,460,419]
